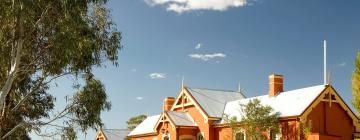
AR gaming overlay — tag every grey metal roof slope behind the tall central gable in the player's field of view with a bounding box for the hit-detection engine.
[187,88,245,118]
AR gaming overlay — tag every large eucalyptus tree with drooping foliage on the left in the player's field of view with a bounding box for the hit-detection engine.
[0,0,122,139]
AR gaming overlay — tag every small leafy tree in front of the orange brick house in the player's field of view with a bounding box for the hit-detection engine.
[224,99,280,139]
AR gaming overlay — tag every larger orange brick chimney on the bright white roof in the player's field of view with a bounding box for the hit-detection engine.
[269,74,284,97]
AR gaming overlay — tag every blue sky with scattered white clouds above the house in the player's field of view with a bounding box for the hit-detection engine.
[31,0,360,139]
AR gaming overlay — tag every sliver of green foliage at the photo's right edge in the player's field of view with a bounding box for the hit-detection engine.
[352,51,360,114]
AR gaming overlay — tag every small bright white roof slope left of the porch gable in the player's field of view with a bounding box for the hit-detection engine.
[128,115,160,136]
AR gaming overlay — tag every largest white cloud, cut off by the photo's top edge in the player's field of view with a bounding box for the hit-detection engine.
[145,0,247,13]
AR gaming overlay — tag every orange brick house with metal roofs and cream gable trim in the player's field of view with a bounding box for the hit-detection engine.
[128,75,360,140]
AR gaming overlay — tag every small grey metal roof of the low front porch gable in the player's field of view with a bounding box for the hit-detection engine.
[166,111,196,126]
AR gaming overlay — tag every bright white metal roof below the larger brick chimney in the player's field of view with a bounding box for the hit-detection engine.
[221,85,326,123]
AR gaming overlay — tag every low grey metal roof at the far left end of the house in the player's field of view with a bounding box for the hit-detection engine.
[102,129,130,140]
